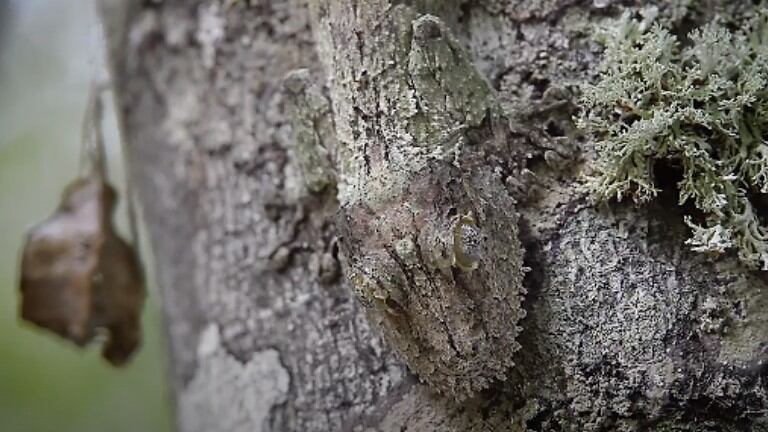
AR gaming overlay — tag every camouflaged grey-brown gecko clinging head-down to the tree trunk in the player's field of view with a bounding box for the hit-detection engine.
[286,11,525,400]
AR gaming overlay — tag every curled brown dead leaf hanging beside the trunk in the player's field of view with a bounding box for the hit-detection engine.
[20,88,145,366]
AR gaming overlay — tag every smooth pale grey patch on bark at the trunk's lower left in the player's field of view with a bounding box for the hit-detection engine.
[179,324,290,432]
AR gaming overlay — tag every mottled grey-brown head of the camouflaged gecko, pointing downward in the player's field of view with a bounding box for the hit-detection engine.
[338,163,525,400]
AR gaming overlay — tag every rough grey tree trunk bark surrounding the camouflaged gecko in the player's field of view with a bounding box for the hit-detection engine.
[102,0,768,432]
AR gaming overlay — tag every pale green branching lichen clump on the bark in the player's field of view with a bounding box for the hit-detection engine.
[578,13,768,270]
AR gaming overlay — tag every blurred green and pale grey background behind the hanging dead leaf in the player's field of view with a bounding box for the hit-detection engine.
[0,0,172,432]
